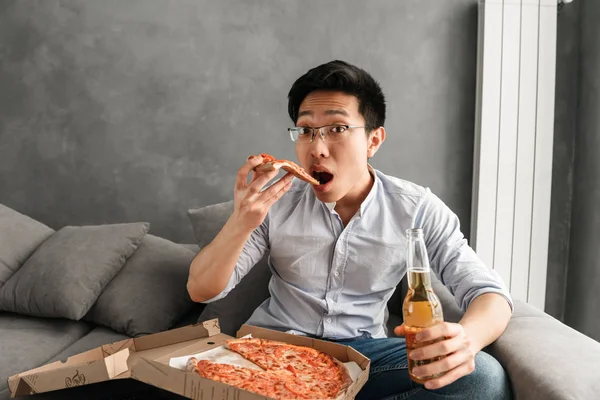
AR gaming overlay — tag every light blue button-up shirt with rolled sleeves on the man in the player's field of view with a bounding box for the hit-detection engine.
[207,168,513,339]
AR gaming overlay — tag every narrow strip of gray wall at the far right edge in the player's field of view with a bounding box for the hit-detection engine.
[565,0,600,340]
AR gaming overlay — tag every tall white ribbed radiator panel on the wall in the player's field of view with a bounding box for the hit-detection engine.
[471,0,557,309]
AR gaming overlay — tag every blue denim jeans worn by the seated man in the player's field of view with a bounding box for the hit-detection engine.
[340,337,512,400]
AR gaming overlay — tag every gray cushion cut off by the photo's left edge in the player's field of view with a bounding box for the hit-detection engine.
[0,204,54,286]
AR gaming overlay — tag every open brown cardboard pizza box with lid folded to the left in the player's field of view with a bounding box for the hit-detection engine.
[8,319,370,400]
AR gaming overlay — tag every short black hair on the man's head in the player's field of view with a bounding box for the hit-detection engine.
[288,60,385,132]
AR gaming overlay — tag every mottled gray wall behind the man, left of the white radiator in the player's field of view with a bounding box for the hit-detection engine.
[0,0,477,242]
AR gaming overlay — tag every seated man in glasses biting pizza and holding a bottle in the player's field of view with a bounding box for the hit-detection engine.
[188,61,512,399]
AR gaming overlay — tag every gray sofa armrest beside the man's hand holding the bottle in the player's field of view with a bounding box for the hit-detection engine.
[485,300,600,400]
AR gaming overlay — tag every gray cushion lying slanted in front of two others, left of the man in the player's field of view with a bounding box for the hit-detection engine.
[0,222,149,320]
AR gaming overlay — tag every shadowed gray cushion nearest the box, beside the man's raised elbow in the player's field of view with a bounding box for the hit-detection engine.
[85,235,196,337]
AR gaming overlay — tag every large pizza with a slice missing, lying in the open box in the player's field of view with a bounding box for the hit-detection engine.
[187,338,352,399]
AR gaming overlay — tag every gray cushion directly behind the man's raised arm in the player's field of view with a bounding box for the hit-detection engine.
[188,201,271,336]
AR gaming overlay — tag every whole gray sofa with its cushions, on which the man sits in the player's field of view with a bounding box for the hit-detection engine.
[0,202,600,400]
